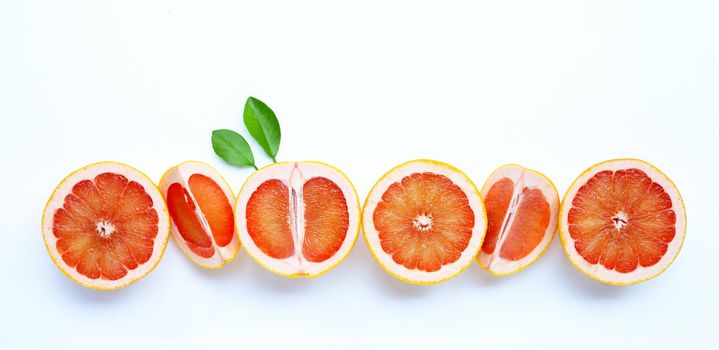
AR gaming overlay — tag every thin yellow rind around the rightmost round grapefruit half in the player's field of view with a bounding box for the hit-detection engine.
[557,158,687,286]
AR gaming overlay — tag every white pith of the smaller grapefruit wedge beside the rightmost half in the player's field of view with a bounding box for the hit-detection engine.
[478,164,559,275]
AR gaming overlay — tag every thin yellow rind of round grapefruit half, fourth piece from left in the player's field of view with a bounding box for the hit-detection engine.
[360,158,487,286]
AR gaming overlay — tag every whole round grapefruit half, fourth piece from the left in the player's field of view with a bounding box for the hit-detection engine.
[362,160,487,284]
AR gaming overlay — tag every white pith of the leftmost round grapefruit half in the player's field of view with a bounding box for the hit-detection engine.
[42,162,170,289]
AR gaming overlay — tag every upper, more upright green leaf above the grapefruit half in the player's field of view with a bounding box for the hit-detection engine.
[243,96,281,163]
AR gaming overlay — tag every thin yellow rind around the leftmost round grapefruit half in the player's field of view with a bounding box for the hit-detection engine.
[40,160,171,290]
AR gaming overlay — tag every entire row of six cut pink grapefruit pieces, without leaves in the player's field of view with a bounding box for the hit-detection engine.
[42,159,686,289]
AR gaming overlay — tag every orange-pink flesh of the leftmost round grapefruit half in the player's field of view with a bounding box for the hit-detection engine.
[52,172,158,280]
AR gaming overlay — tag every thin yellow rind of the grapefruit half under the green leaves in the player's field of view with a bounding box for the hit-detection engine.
[234,160,362,279]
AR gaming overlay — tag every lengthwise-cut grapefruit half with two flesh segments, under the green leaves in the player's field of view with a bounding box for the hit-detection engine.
[235,162,360,277]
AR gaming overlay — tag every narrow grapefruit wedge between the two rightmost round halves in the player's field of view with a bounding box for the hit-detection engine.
[477,164,559,276]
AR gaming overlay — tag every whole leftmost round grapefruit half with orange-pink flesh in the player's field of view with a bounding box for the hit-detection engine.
[42,162,170,289]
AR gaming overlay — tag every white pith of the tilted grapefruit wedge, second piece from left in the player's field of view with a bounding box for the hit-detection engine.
[160,161,240,267]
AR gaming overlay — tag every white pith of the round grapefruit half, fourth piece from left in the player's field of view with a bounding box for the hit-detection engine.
[362,160,487,284]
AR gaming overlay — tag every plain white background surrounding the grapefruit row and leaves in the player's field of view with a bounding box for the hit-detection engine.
[0,0,719,349]
